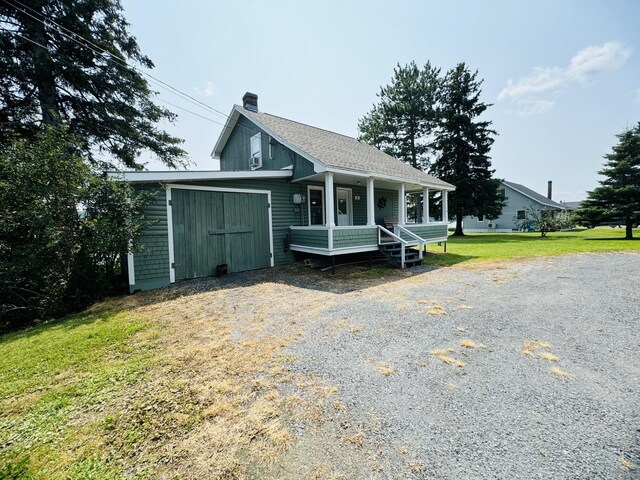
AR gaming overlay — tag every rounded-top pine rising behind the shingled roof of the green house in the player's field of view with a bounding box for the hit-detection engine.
[358,62,440,169]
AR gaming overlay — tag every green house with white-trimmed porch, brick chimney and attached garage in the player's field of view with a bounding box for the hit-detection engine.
[121,93,455,292]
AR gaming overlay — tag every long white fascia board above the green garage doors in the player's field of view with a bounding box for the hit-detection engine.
[109,170,293,183]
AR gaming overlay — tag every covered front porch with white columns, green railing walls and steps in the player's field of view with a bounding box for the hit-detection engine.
[289,172,449,268]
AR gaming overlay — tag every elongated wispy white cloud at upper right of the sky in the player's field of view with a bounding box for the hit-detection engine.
[498,41,631,116]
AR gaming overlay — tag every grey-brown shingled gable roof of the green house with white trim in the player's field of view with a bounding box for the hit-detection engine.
[213,105,455,190]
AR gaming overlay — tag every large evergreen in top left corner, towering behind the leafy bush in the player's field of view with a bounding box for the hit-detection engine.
[0,0,185,168]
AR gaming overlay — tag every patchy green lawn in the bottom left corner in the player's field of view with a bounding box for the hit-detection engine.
[0,312,157,479]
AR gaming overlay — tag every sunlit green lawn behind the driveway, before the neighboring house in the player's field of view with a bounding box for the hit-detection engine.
[425,227,640,265]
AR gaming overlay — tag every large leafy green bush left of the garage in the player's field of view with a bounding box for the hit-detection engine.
[0,127,147,330]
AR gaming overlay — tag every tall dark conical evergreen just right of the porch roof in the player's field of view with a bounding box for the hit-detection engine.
[430,63,505,235]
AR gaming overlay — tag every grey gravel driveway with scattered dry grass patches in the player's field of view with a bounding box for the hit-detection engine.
[272,253,640,479]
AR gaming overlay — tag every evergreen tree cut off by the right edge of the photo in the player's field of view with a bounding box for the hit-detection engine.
[578,122,640,240]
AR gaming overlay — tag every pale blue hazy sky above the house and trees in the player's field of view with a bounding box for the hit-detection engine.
[123,0,640,201]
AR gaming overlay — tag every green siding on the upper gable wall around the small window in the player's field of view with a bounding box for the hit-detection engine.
[220,116,302,174]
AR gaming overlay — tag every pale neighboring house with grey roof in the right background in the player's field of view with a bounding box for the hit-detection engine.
[463,180,566,233]
